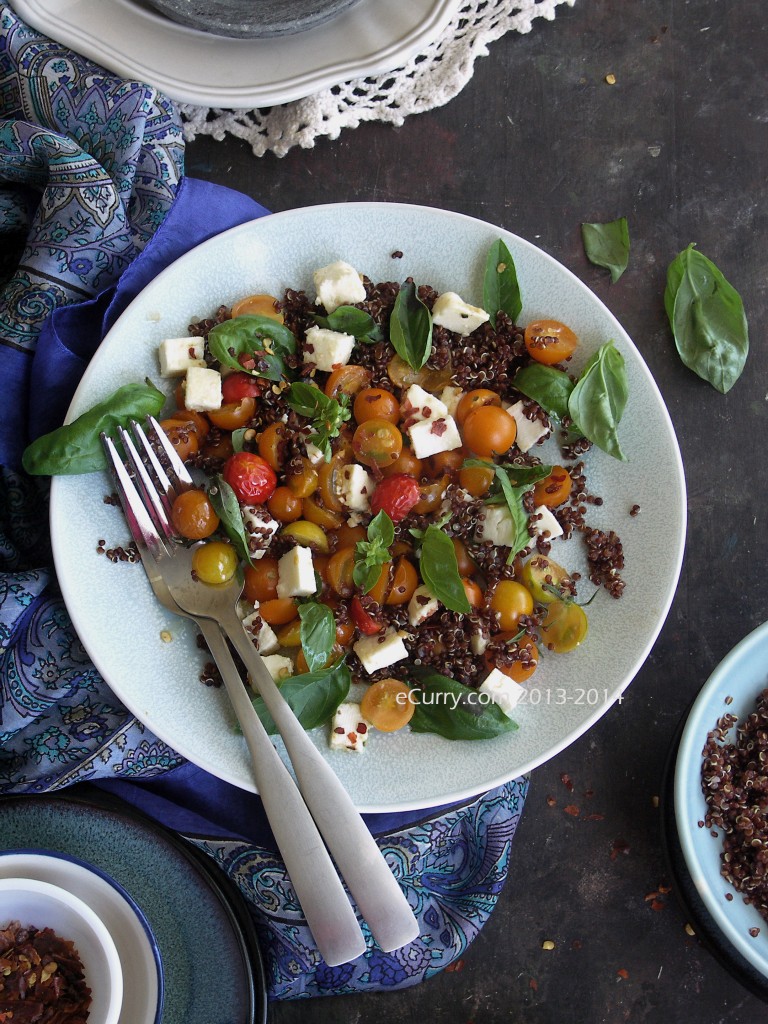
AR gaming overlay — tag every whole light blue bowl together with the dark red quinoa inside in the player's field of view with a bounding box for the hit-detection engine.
[675,623,768,979]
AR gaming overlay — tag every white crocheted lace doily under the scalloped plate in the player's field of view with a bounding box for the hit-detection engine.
[181,0,575,157]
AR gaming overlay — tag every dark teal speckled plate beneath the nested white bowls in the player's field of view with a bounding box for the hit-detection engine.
[0,794,266,1024]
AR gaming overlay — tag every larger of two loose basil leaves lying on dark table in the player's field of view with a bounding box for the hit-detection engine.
[664,245,750,394]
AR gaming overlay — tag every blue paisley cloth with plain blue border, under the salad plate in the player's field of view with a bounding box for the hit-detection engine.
[0,3,527,998]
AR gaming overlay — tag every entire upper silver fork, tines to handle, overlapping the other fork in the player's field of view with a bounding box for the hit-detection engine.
[102,418,419,951]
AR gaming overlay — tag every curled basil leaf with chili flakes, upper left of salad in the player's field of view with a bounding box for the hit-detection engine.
[208,314,296,383]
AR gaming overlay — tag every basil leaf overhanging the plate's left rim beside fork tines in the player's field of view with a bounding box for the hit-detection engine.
[22,381,165,476]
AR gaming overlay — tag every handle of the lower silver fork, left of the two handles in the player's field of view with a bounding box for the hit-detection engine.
[196,618,366,967]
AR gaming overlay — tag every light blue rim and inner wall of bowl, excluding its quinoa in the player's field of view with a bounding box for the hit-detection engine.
[675,623,768,978]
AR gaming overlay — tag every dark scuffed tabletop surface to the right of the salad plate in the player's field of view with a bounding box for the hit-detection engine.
[187,0,768,1024]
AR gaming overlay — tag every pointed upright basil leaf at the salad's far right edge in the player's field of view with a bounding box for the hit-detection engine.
[568,341,629,461]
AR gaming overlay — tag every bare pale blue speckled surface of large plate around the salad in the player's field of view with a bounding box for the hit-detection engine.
[46,203,685,812]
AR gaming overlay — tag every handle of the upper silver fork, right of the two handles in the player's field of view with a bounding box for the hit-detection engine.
[219,610,419,952]
